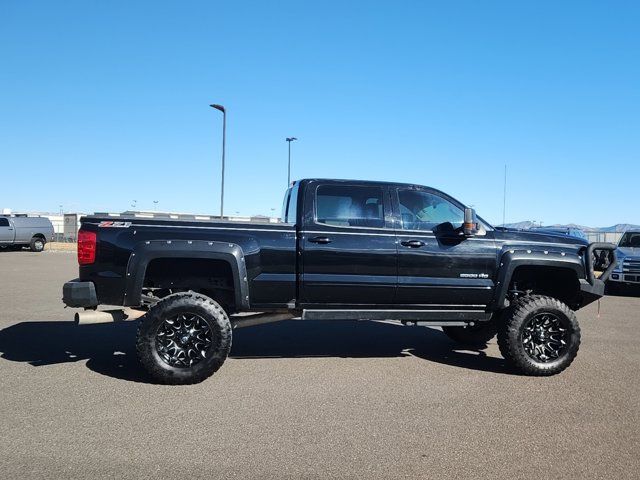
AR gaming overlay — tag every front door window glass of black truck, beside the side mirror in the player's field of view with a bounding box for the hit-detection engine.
[398,190,464,230]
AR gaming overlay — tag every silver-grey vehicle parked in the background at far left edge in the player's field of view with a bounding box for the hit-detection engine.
[0,216,54,252]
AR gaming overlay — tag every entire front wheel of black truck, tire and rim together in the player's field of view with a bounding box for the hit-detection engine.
[498,295,580,376]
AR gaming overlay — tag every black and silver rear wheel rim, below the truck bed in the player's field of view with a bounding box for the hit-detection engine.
[156,313,213,368]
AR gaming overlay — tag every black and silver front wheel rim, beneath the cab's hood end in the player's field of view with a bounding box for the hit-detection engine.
[522,313,569,363]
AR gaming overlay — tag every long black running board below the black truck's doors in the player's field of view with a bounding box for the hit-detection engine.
[302,309,491,325]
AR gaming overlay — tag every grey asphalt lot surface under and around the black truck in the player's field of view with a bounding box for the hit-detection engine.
[0,252,640,479]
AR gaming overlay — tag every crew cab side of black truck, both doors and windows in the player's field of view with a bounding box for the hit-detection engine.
[298,180,497,315]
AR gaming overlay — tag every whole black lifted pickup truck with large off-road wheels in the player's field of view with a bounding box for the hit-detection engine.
[63,179,616,384]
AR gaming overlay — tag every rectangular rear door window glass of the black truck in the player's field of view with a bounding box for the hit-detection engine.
[316,185,384,228]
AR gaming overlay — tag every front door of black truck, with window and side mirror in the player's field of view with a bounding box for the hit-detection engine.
[393,188,496,309]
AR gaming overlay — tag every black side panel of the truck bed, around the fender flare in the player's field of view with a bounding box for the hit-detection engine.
[80,217,296,308]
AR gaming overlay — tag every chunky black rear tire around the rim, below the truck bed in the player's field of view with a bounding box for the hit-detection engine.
[136,292,232,385]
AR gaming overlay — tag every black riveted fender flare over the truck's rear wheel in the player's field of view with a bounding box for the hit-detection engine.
[123,240,250,309]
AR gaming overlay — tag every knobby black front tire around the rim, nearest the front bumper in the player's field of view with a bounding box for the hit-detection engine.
[498,295,580,376]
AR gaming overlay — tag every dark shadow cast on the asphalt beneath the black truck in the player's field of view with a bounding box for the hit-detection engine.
[0,320,516,383]
